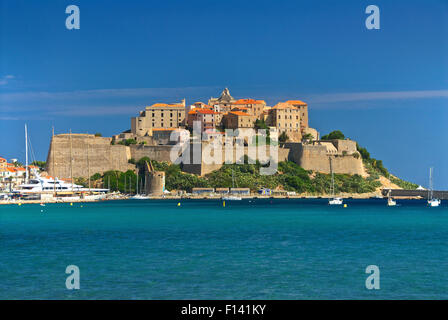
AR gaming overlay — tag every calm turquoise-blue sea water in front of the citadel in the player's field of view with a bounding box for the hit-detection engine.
[0,200,448,299]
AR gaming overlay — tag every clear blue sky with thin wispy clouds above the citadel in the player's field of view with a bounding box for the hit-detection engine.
[0,0,448,189]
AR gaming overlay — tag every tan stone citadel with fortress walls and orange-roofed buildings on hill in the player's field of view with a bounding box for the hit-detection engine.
[46,88,366,178]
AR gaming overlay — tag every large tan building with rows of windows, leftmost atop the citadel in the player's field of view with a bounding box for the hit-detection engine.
[131,99,185,136]
